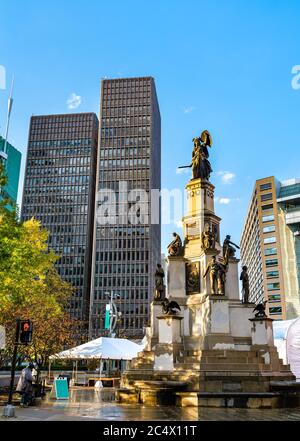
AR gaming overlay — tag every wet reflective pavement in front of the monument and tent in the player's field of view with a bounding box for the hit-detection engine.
[0,388,300,421]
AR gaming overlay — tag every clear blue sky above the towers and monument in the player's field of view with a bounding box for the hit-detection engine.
[0,0,300,253]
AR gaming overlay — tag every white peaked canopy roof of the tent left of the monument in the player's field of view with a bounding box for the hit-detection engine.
[50,337,143,360]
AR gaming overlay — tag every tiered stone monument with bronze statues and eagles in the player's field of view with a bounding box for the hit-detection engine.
[117,130,299,408]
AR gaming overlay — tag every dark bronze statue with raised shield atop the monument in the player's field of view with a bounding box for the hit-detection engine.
[178,130,212,181]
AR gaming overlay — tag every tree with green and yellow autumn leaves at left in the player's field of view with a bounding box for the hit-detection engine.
[0,163,78,364]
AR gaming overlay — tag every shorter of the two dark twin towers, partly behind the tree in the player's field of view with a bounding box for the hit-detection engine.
[22,113,98,329]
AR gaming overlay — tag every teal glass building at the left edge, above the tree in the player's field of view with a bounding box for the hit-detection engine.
[0,136,22,207]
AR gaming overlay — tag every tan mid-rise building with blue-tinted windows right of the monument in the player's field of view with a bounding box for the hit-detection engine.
[241,176,300,320]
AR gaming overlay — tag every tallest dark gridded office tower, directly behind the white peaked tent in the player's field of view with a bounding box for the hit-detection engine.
[90,77,161,338]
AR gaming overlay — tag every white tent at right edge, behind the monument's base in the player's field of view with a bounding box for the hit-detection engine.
[273,317,300,380]
